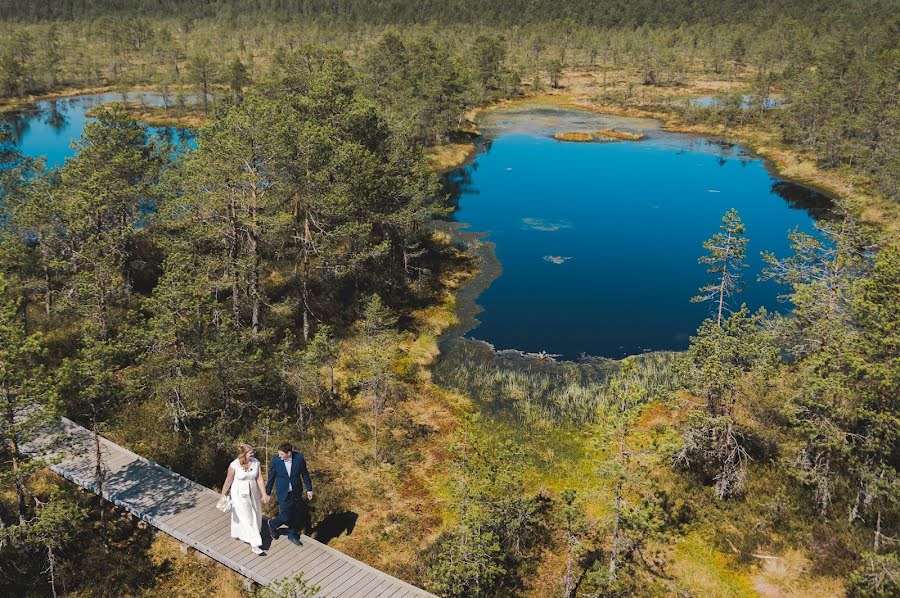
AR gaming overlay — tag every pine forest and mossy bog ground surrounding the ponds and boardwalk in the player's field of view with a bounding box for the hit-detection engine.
[0,0,900,598]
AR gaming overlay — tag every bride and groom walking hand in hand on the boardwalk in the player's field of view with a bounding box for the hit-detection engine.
[222,442,314,554]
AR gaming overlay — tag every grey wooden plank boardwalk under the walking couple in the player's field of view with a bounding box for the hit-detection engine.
[30,418,432,598]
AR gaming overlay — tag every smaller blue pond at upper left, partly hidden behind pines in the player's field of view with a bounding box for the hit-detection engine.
[0,92,194,168]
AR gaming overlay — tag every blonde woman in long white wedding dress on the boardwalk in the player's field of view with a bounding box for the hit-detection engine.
[222,444,269,554]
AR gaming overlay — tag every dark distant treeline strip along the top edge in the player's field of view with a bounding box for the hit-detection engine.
[0,0,896,27]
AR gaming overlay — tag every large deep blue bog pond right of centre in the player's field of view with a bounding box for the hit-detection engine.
[451,106,828,359]
